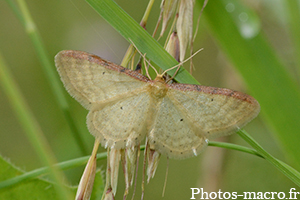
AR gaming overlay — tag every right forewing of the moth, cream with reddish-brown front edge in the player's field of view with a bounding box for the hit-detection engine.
[168,83,260,139]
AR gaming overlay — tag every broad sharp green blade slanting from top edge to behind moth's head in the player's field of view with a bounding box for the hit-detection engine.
[86,0,199,84]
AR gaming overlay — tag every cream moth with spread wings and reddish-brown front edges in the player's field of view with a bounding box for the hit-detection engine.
[55,50,260,159]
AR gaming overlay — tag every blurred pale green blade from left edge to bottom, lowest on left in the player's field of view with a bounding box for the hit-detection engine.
[0,54,70,199]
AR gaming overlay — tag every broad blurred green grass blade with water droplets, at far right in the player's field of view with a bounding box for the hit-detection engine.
[199,0,300,169]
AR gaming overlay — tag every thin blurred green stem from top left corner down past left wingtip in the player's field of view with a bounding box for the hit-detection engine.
[6,0,88,154]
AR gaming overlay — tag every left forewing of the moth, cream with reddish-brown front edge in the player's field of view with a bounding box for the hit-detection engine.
[55,50,149,110]
